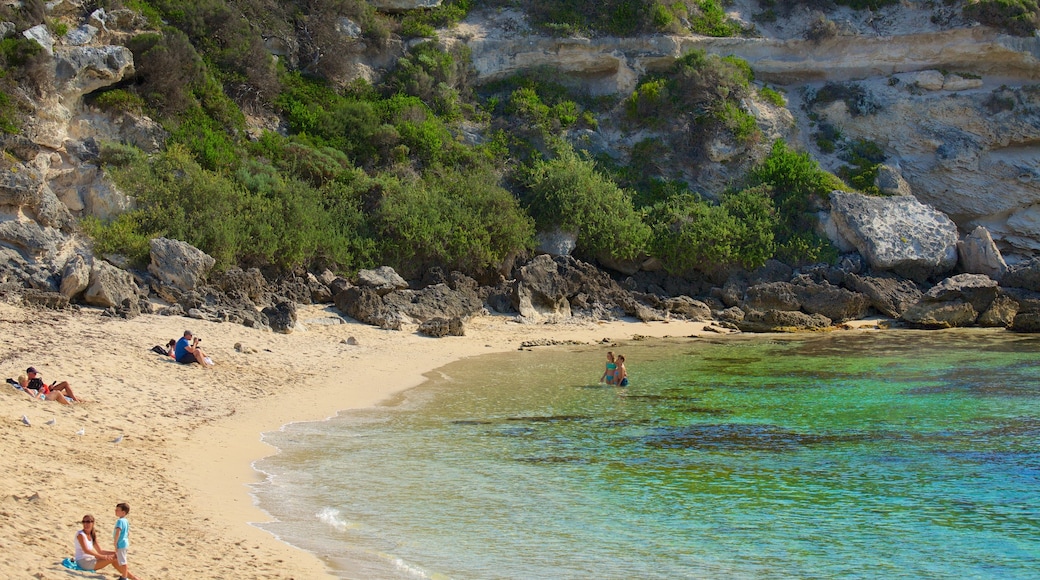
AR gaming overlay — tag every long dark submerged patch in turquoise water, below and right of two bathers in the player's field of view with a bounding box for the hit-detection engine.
[643,423,873,451]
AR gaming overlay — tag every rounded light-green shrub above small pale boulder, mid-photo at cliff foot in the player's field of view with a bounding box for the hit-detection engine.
[524,147,650,259]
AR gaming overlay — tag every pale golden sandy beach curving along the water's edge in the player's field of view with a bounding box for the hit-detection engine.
[0,304,732,580]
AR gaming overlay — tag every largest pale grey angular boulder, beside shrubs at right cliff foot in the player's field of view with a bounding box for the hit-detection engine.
[831,191,958,282]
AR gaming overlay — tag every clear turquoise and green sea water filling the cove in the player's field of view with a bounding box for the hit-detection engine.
[256,331,1040,579]
